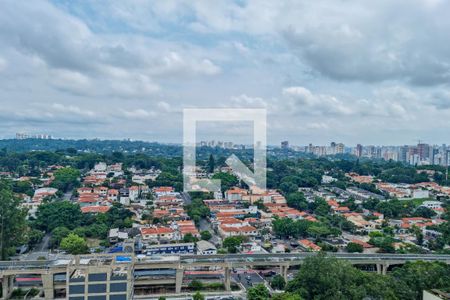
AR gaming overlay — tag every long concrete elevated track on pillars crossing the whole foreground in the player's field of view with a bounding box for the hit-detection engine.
[0,252,450,299]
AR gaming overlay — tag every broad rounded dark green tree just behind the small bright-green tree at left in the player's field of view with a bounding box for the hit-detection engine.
[34,201,83,232]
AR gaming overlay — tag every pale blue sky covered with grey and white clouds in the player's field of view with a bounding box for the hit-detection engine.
[0,0,450,145]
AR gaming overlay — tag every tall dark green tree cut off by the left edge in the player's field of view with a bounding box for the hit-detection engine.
[0,180,27,260]
